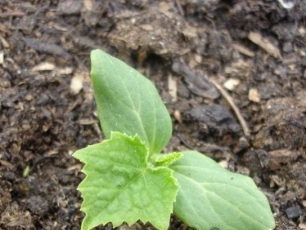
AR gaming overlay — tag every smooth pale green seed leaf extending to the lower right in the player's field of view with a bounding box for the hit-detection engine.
[170,151,275,230]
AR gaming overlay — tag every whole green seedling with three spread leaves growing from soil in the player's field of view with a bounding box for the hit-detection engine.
[73,50,275,230]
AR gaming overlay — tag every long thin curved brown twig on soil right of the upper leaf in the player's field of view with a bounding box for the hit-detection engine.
[209,79,250,137]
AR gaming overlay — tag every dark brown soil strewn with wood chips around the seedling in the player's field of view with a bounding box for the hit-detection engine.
[0,0,306,230]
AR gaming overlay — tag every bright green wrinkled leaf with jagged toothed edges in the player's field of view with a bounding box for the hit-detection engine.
[74,132,178,230]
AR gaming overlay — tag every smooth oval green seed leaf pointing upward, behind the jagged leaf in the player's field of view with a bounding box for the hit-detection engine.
[91,50,172,153]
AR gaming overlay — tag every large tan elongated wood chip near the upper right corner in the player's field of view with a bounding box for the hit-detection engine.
[248,32,282,58]
